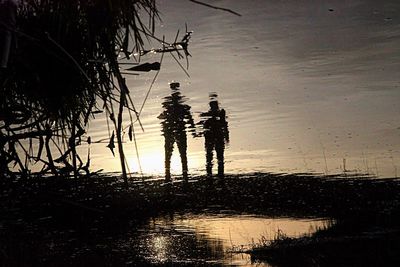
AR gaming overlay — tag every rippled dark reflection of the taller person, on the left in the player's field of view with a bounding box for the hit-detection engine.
[158,82,194,181]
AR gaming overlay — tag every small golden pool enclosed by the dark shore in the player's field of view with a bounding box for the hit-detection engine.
[119,214,330,266]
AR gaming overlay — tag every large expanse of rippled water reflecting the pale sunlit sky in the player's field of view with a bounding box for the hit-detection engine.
[86,0,400,177]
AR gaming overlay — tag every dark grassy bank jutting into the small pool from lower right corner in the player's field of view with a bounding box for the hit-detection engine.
[248,226,400,266]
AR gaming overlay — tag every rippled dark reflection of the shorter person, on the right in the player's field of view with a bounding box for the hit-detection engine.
[200,93,229,178]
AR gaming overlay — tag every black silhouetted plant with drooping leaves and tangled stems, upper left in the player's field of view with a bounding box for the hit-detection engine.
[0,0,239,183]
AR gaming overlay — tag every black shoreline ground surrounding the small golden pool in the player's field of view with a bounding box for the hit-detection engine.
[0,173,400,266]
